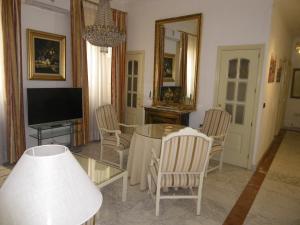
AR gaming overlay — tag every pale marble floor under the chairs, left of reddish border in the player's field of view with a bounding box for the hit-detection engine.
[81,143,252,225]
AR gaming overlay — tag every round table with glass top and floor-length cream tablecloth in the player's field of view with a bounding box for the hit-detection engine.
[127,124,184,190]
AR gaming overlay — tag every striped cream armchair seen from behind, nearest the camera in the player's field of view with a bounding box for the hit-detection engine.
[148,127,212,216]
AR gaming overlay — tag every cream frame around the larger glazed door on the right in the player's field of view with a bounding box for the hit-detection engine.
[214,44,265,170]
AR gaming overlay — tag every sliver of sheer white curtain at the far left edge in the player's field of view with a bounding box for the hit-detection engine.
[0,0,7,165]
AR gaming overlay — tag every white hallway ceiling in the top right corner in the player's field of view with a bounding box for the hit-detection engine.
[275,0,300,36]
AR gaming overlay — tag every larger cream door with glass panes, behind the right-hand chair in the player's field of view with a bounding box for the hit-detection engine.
[217,49,260,167]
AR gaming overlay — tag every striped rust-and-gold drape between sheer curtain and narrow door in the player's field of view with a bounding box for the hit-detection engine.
[111,9,126,122]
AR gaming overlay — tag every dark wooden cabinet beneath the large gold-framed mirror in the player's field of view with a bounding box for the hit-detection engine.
[145,107,191,126]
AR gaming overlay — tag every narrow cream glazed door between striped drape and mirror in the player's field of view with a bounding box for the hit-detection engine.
[125,52,144,125]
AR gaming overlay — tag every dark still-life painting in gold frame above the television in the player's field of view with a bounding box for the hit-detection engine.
[27,29,66,80]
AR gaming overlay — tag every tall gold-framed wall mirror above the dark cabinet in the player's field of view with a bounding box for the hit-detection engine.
[153,14,201,110]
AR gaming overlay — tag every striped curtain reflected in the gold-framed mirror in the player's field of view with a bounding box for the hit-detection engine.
[180,32,189,97]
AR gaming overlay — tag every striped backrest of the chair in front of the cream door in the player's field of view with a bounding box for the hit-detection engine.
[201,108,231,136]
